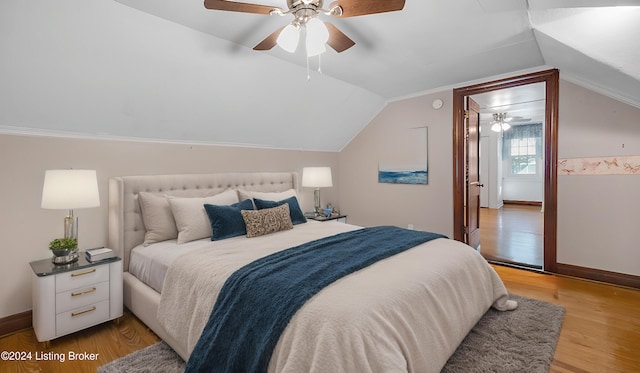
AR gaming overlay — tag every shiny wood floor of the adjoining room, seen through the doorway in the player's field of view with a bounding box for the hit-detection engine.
[480,205,544,270]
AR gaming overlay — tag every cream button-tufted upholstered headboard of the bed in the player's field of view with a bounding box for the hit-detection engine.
[109,172,298,271]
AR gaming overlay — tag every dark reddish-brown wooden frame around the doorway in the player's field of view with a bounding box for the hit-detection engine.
[453,69,560,273]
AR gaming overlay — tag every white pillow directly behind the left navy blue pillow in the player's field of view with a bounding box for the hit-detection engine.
[167,189,238,244]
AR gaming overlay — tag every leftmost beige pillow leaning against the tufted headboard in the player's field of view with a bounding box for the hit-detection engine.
[138,192,178,246]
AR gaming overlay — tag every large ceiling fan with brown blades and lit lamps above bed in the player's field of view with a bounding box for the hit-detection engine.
[204,0,405,57]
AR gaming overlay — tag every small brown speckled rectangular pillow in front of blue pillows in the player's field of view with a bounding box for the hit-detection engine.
[240,203,293,237]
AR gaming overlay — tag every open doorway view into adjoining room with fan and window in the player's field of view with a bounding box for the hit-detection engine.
[470,83,546,270]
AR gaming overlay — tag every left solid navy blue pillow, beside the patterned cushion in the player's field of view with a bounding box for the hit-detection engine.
[204,199,254,241]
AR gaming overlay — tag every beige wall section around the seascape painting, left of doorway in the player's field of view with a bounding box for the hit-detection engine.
[340,91,453,236]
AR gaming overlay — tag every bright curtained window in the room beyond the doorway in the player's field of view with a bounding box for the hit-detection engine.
[502,123,542,176]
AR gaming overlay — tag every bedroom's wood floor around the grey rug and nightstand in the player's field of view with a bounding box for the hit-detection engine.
[0,266,640,373]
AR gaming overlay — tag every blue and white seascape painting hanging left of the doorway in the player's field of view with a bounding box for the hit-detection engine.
[378,127,429,185]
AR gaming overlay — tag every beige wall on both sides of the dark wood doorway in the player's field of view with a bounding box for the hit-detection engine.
[340,80,640,276]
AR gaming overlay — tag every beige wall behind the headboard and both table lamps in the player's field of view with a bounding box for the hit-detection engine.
[0,135,339,318]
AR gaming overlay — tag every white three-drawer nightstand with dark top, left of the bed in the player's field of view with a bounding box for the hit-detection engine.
[30,252,123,342]
